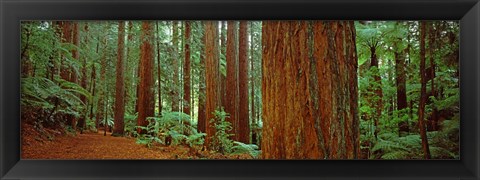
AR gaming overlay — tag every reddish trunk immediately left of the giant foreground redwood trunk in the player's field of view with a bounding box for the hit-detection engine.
[237,21,250,143]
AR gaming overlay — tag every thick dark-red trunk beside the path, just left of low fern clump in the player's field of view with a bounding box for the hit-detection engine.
[137,21,155,133]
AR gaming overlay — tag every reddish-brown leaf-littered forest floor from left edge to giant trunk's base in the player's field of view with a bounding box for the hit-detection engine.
[21,123,249,159]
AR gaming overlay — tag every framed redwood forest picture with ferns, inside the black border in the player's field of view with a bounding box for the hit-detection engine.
[20,21,460,160]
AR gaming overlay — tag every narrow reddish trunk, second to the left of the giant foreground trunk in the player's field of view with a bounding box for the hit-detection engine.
[225,21,238,140]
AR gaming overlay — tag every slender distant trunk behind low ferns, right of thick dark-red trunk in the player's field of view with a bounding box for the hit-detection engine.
[183,21,191,114]
